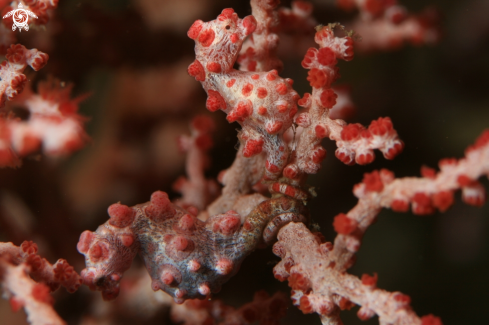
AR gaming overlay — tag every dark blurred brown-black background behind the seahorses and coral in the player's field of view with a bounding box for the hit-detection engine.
[0,0,489,325]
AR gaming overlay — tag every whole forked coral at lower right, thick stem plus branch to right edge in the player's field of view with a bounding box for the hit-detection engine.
[273,130,489,325]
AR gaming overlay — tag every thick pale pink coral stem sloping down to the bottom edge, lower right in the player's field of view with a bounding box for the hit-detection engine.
[273,223,434,325]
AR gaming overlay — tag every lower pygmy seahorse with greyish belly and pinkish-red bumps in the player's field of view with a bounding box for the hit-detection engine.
[78,191,308,303]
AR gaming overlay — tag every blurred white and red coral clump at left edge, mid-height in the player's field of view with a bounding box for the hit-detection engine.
[0,78,88,167]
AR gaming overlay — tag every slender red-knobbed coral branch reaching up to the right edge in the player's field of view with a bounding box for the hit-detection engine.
[332,130,489,270]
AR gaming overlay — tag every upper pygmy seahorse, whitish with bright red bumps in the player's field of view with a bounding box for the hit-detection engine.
[187,9,300,179]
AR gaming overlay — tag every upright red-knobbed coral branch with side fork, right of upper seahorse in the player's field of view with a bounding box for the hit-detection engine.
[284,24,403,184]
